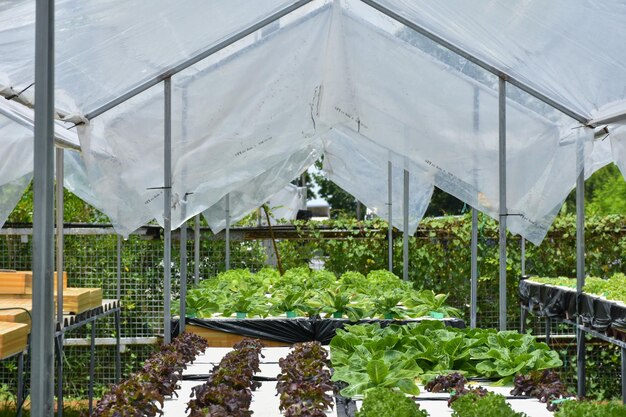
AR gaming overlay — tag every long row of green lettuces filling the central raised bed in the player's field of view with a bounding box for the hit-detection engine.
[176,267,461,321]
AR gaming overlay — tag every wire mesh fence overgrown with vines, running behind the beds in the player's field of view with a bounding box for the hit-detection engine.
[0,221,619,397]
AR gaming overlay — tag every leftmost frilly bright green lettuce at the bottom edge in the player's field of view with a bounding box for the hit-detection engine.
[355,388,429,417]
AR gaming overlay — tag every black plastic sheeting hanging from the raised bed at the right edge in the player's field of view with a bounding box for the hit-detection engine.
[519,280,626,332]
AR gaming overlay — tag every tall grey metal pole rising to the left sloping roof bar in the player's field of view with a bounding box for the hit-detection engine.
[163,78,172,344]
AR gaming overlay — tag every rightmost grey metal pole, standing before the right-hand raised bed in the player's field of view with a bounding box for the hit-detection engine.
[576,144,587,397]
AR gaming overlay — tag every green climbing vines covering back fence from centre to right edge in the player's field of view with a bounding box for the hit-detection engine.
[279,213,626,327]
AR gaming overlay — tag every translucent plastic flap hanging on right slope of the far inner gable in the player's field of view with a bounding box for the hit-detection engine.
[324,123,434,235]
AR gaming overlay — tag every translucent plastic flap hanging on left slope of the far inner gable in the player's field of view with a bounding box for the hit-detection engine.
[202,143,321,233]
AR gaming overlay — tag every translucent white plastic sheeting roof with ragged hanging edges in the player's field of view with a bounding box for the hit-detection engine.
[0,0,626,243]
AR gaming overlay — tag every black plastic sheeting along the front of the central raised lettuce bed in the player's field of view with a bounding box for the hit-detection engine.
[172,317,465,345]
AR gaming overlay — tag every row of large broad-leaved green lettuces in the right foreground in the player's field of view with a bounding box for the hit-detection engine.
[330,321,562,397]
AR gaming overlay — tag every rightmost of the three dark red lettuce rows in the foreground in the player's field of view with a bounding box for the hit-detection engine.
[276,342,333,417]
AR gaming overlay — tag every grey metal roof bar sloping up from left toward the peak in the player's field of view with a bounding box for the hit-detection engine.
[85,0,313,120]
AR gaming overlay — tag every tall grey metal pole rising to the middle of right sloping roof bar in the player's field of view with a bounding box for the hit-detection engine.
[498,78,507,330]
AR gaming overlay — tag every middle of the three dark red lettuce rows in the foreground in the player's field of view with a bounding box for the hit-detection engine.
[187,338,263,417]
